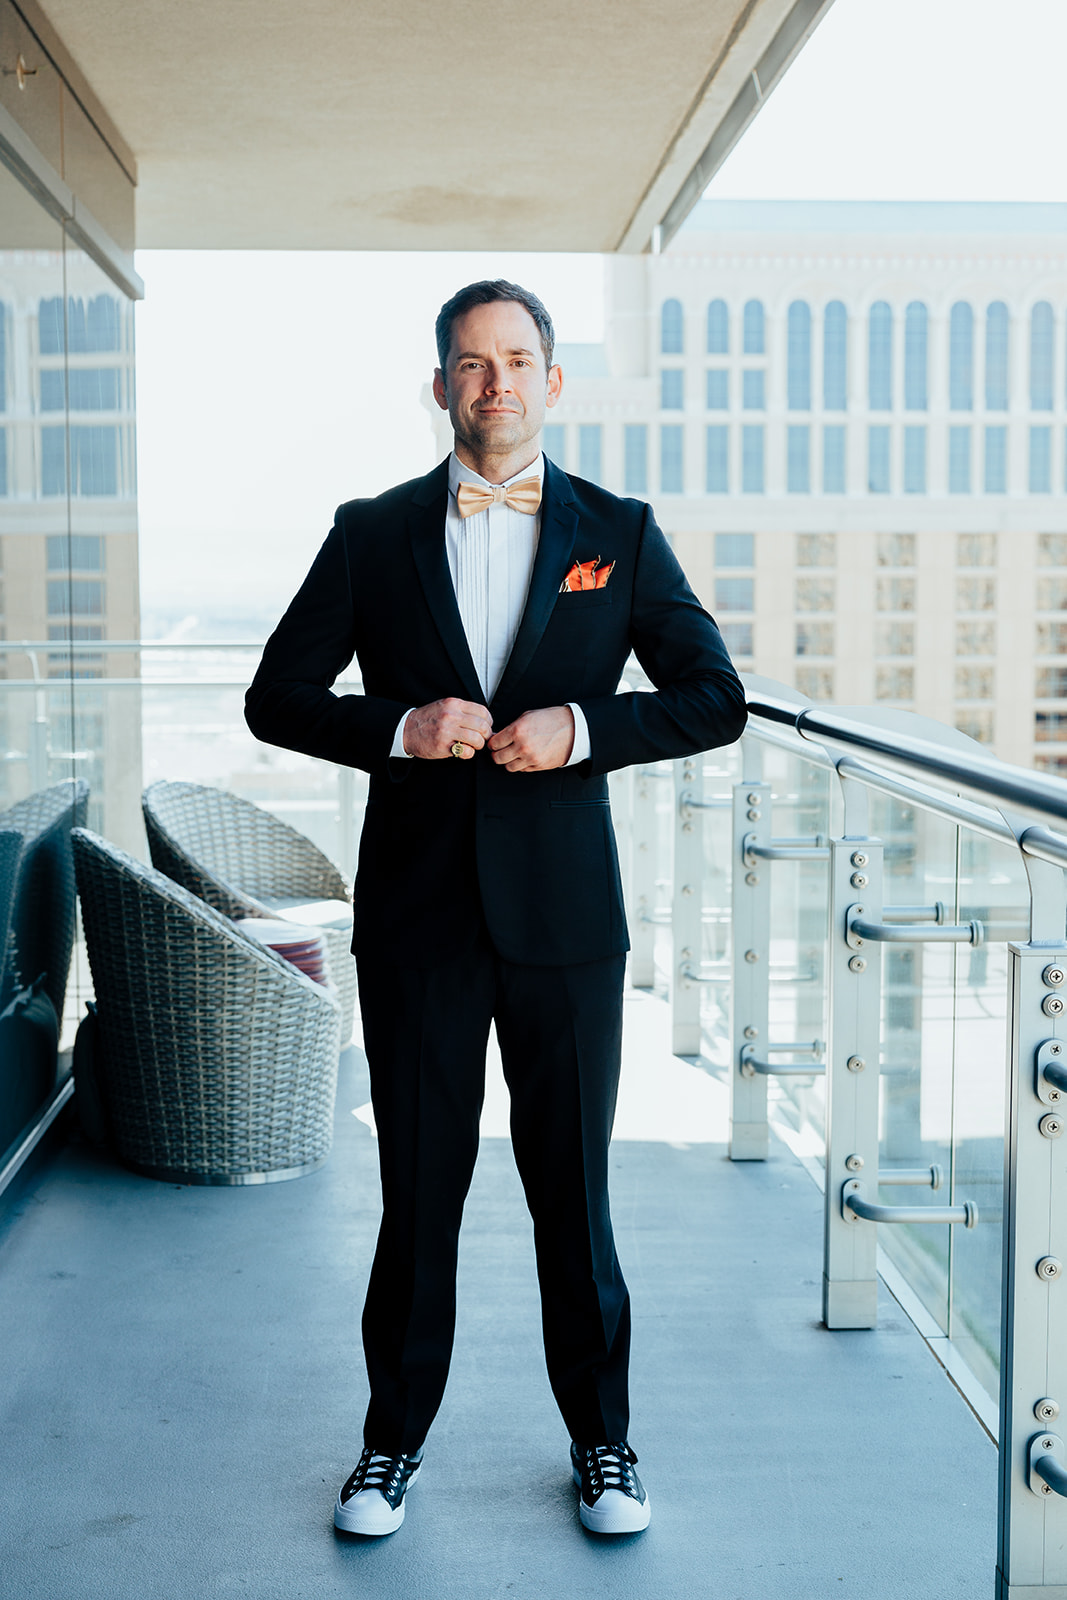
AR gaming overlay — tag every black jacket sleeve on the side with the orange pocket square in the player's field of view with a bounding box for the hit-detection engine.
[579,509,747,776]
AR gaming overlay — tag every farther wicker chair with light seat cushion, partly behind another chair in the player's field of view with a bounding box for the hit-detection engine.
[141,781,355,1043]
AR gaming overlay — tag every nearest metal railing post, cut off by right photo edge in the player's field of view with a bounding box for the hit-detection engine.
[997,854,1067,1600]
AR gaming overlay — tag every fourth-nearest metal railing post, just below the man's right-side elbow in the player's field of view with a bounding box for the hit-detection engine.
[670,755,704,1056]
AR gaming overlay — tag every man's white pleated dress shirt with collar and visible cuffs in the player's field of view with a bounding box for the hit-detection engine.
[389,453,589,766]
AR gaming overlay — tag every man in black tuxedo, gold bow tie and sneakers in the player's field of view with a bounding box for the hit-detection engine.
[246,282,745,1534]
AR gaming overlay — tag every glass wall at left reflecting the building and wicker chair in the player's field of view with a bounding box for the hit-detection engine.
[0,103,144,1165]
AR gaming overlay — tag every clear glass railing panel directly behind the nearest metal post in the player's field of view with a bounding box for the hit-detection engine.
[949,830,1029,1400]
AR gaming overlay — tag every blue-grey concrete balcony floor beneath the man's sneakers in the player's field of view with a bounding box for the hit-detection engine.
[0,1017,997,1600]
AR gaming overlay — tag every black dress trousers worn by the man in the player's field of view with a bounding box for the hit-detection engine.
[357,928,630,1454]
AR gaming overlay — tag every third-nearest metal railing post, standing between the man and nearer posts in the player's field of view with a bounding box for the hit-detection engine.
[729,739,771,1162]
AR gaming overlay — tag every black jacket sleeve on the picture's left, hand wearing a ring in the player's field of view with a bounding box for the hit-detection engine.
[245,509,410,774]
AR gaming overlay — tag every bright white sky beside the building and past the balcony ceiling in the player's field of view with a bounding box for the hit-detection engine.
[138,0,1067,626]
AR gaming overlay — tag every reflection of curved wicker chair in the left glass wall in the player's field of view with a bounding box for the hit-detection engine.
[0,778,90,1019]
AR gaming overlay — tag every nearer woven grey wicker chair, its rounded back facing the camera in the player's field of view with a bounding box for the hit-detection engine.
[72,829,341,1184]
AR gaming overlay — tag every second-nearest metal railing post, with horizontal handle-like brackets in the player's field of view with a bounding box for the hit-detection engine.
[822,779,883,1328]
